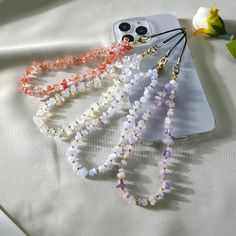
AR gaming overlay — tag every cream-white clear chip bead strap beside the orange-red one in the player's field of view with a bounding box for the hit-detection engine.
[33,29,186,139]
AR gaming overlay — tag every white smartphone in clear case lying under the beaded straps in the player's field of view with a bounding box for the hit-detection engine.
[112,14,215,141]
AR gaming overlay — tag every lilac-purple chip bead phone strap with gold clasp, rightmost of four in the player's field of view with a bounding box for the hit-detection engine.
[116,33,187,206]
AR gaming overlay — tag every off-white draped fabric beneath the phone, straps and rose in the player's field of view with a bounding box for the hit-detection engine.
[0,0,236,236]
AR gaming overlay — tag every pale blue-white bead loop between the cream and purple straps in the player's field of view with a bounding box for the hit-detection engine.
[66,67,158,177]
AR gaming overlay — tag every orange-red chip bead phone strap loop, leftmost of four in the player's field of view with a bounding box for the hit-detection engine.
[17,39,133,98]
